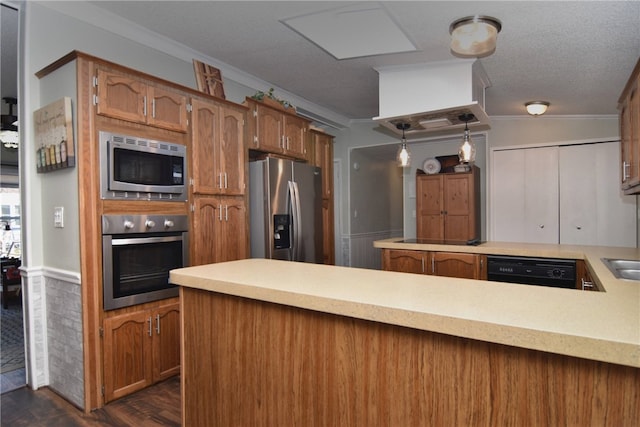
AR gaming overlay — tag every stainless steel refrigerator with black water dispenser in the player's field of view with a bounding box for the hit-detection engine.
[249,157,323,264]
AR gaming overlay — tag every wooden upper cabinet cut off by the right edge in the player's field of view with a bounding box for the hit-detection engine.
[618,60,640,194]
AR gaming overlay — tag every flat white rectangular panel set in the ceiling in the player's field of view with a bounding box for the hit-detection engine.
[281,3,416,59]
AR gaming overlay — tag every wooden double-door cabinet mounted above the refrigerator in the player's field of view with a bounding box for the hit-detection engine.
[246,98,310,160]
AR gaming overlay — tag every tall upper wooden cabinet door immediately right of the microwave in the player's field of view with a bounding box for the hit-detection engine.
[191,99,223,194]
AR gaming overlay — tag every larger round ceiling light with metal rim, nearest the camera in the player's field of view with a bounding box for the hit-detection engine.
[449,15,502,58]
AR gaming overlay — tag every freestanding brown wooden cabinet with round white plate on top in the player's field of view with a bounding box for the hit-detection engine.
[416,166,480,242]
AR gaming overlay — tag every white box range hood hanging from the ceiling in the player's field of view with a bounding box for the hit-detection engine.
[373,59,490,135]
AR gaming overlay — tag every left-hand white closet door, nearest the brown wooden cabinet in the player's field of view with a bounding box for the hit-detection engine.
[491,147,559,244]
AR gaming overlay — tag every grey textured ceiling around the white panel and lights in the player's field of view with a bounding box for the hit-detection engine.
[84,1,640,119]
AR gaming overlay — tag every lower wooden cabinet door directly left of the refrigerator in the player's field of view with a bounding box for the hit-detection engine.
[220,197,249,262]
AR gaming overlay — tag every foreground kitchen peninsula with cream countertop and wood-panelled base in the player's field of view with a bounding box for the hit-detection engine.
[171,248,640,426]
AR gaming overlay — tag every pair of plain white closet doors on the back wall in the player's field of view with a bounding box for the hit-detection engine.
[490,141,636,247]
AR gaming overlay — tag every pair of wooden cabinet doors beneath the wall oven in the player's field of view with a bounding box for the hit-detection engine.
[103,301,180,403]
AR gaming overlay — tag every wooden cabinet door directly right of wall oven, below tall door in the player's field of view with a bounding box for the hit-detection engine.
[190,197,221,265]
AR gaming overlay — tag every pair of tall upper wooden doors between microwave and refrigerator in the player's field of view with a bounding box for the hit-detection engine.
[190,98,246,195]
